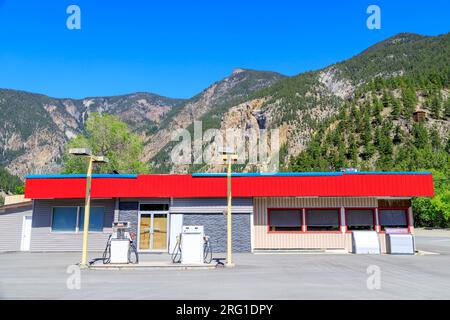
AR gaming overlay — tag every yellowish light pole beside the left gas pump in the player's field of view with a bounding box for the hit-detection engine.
[69,148,108,268]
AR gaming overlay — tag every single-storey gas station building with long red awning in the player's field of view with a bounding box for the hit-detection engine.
[16,172,434,253]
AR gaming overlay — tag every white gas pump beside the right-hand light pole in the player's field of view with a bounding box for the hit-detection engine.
[181,226,205,264]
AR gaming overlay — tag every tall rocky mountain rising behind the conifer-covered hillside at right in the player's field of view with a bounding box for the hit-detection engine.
[189,33,450,171]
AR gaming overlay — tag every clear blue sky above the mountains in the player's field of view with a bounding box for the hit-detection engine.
[0,0,450,98]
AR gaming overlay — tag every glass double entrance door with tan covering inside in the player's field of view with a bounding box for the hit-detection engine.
[139,212,168,251]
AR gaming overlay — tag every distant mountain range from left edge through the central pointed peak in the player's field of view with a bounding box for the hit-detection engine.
[0,69,284,177]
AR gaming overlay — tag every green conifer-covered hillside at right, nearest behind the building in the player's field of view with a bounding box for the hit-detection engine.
[284,66,450,227]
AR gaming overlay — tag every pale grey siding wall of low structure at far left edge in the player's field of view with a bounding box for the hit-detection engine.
[0,205,32,251]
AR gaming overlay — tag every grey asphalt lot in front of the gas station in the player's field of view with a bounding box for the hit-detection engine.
[0,231,450,299]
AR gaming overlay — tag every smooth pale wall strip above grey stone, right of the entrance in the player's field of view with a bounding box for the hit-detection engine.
[170,198,253,214]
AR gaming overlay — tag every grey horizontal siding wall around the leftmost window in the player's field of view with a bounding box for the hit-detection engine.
[30,199,114,251]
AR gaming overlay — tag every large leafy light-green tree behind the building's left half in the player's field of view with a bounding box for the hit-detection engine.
[63,113,150,173]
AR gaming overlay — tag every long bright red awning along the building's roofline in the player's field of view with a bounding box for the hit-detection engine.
[25,173,434,199]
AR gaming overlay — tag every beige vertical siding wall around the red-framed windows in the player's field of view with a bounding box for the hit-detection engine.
[253,197,377,251]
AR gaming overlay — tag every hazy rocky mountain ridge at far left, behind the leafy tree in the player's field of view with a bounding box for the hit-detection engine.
[0,90,184,177]
